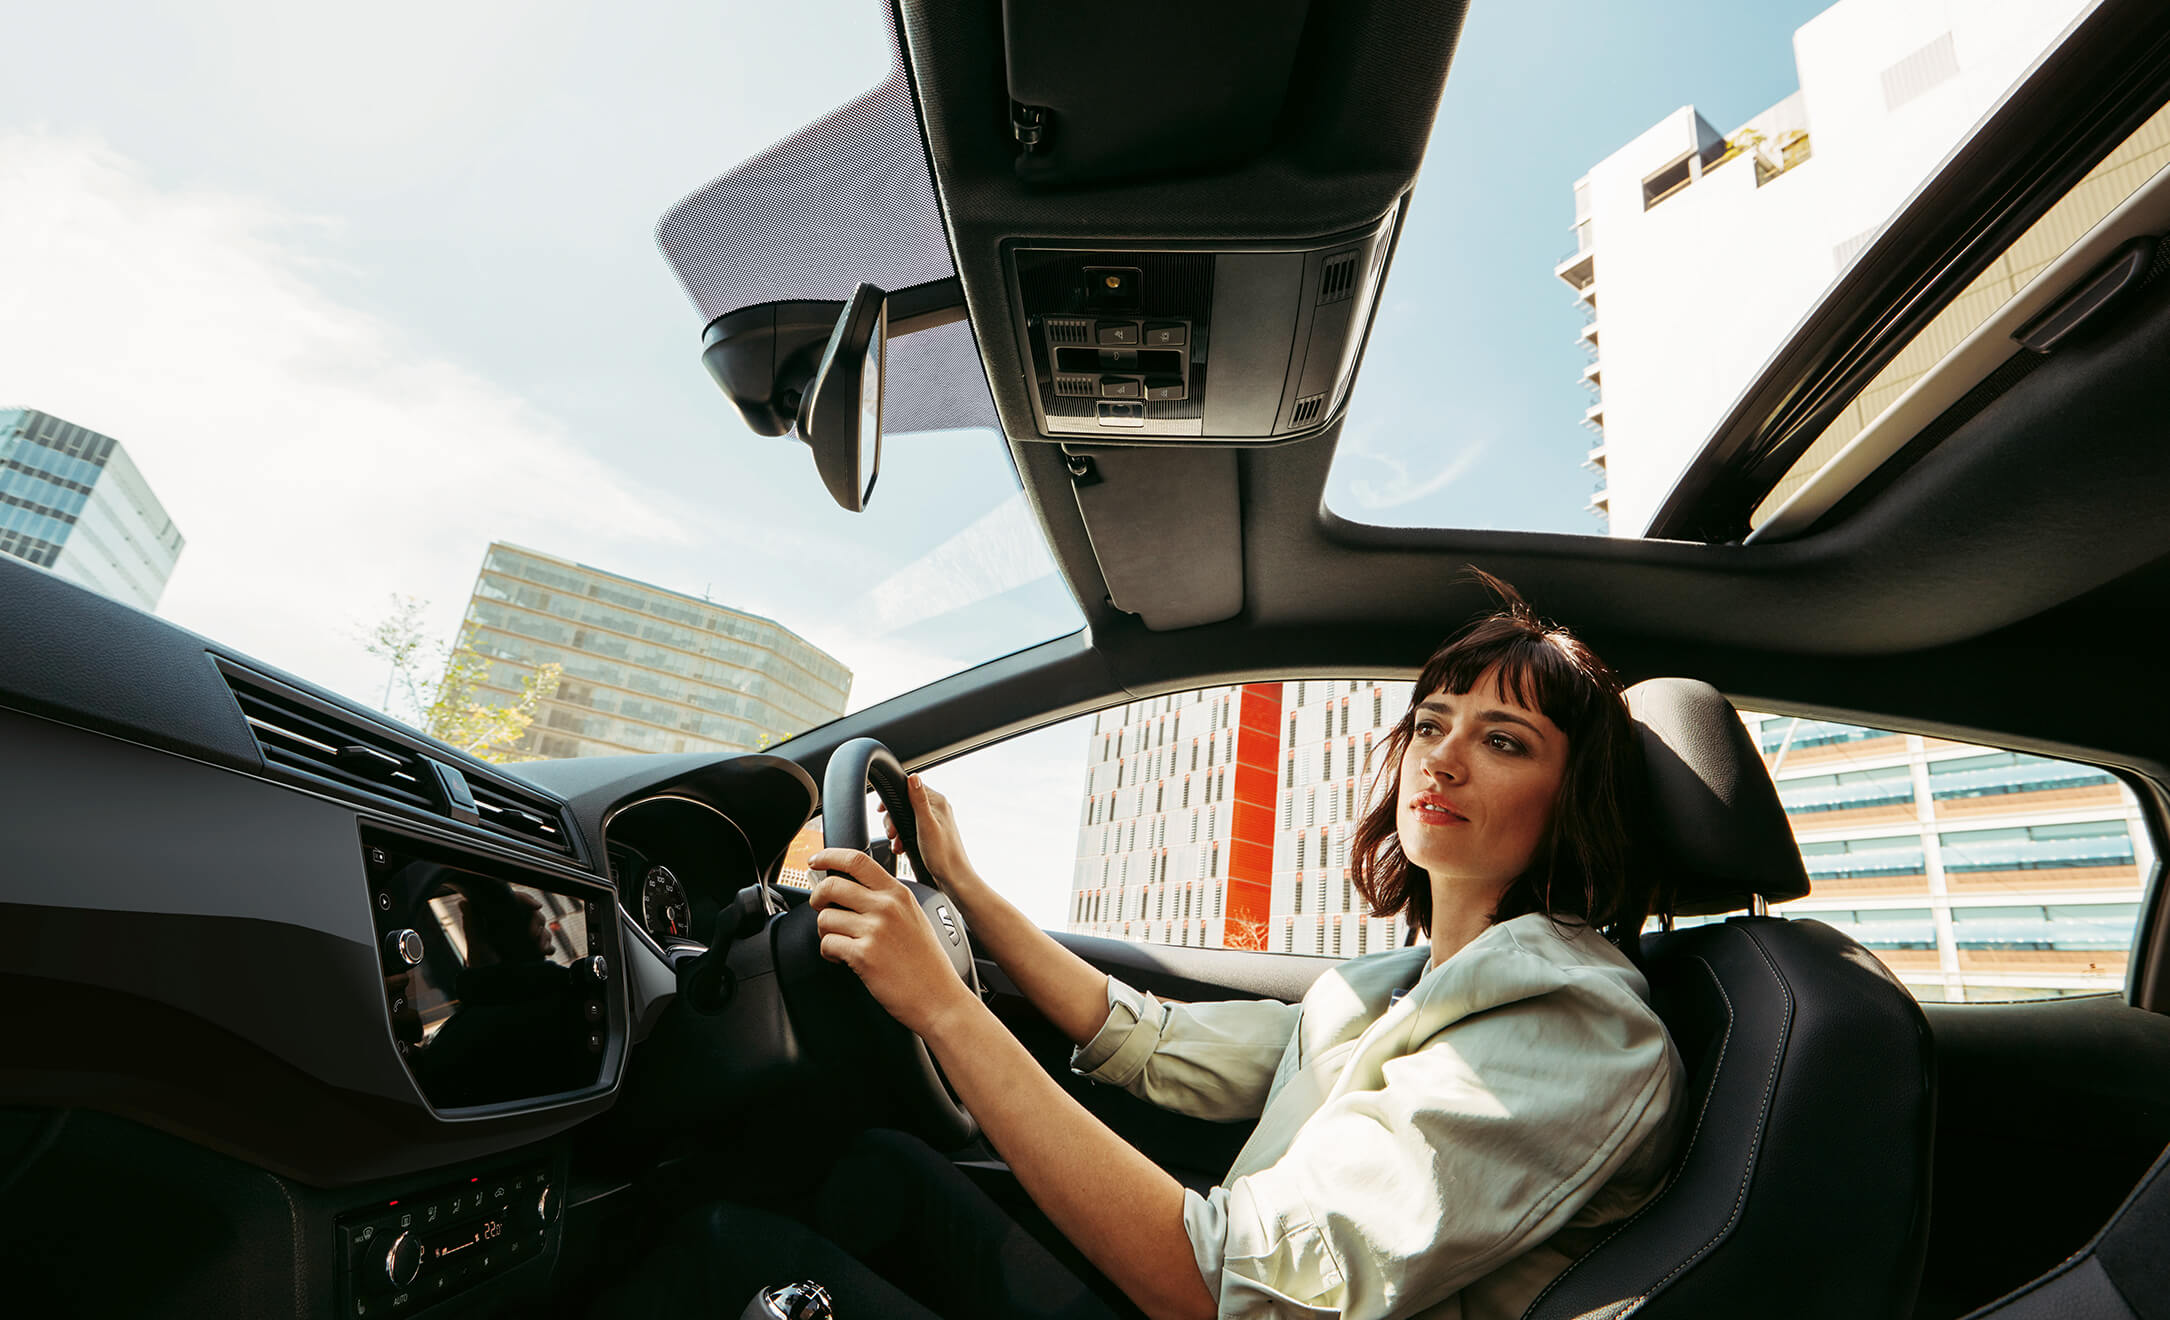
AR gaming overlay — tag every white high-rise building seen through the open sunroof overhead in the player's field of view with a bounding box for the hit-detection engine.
[1554,0,2088,536]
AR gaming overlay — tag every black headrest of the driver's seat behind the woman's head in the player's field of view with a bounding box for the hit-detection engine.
[1628,677,1808,916]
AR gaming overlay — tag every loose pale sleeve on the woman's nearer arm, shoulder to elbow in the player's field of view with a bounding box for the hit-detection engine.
[1183,959,1680,1320]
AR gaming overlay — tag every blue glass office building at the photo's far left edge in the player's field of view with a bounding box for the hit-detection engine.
[0,408,184,610]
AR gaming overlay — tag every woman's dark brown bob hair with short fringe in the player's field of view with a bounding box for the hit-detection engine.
[1350,569,1671,957]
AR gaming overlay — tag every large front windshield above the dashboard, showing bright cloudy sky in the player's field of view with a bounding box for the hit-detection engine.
[0,0,1081,758]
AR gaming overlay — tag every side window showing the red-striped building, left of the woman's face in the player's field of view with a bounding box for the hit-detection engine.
[902,680,1411,957]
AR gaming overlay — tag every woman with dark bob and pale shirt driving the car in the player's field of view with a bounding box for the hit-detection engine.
[603,573,1684,1320]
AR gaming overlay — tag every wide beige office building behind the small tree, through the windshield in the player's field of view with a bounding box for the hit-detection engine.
[460,543,851,758]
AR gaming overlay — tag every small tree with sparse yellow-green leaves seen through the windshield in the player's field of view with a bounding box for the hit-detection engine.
[362,595,564,764]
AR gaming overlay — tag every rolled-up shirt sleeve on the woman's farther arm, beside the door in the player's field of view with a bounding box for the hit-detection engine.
[1070,977,1302,1120]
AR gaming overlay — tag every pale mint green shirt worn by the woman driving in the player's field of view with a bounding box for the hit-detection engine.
[1072,914,1686,1320]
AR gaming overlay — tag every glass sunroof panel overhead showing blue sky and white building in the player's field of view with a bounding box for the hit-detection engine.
[1328,0,2091,536]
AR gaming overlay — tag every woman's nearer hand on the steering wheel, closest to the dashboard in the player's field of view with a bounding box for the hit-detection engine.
[807,846,979,1036]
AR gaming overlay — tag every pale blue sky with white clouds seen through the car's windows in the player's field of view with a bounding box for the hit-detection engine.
[0,0,1825,923]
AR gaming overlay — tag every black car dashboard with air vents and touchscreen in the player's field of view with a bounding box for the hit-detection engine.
[0,556,818,1316]
